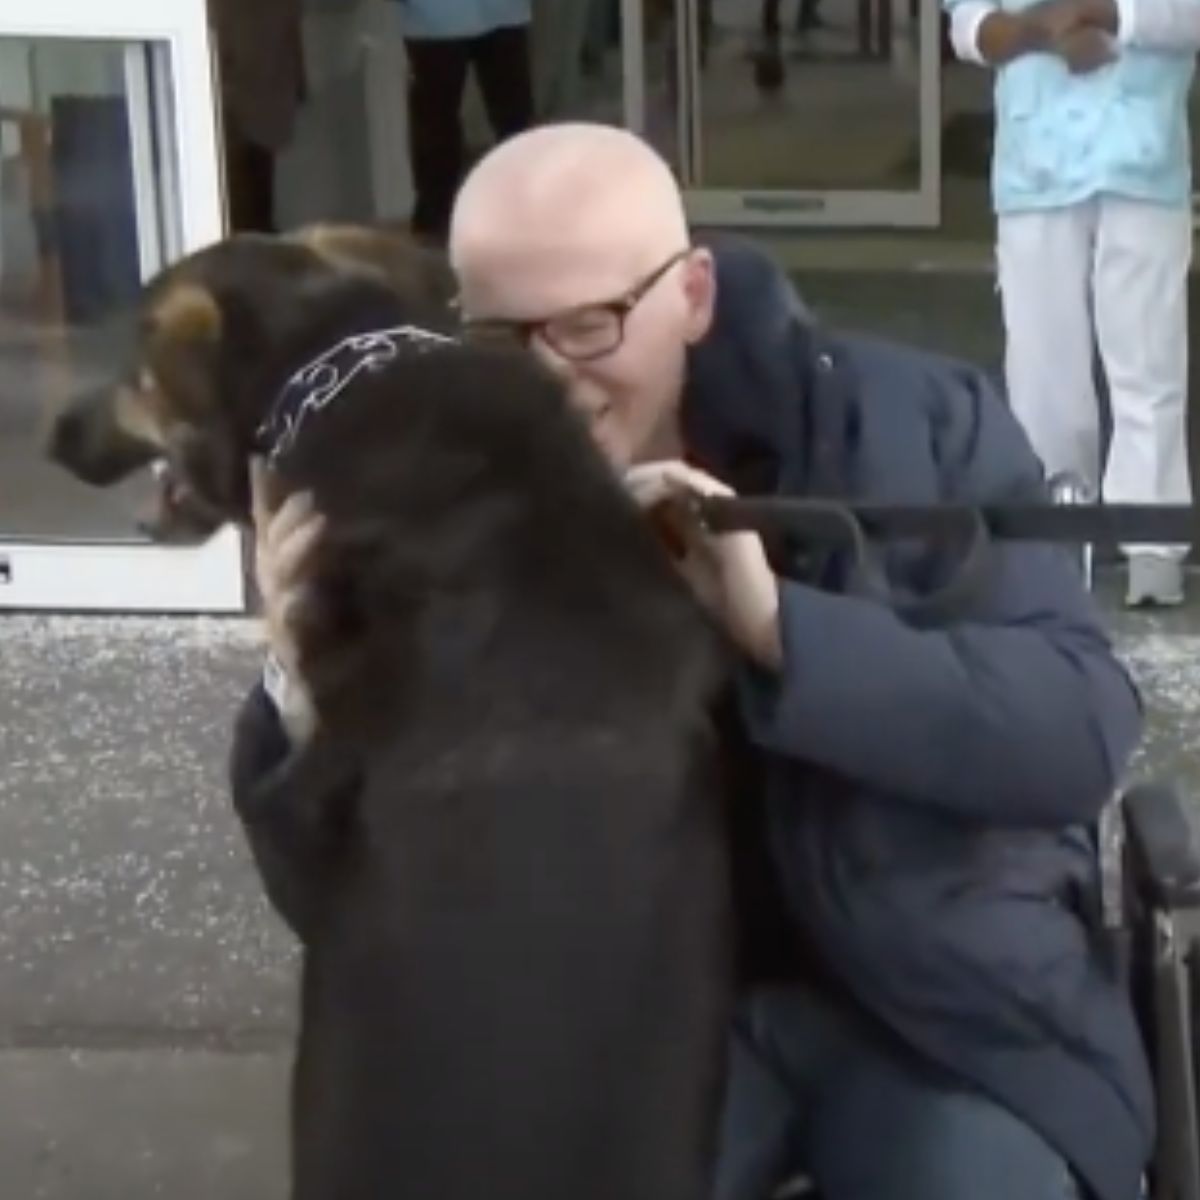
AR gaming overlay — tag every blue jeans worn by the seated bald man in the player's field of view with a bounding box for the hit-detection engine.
[715,988,1081,1200]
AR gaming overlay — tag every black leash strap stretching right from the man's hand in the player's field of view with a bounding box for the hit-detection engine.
[696,497,1198,546]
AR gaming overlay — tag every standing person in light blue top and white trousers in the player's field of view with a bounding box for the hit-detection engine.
[946,0,1200,605]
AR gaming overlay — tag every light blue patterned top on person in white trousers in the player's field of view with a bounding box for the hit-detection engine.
[946,0,1195,214]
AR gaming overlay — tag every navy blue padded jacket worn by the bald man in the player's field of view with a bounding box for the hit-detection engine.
[684,242,1153,1200]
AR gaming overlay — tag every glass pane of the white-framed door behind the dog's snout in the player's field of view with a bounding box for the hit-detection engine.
[0,38,179,541]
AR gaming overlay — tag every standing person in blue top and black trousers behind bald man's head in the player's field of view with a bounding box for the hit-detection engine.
[398,0,534,241]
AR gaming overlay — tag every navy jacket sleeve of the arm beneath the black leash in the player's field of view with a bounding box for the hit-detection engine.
[744,350,1141,827]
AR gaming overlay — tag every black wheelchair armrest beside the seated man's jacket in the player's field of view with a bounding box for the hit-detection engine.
[1121,784,1200,908]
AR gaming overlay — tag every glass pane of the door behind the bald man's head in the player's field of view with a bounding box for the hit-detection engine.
[647,0,920,192]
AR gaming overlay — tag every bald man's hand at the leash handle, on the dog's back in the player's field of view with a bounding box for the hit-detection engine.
[625,461,784,670]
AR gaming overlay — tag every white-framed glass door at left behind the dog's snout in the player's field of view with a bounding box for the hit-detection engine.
[0,0,244,612]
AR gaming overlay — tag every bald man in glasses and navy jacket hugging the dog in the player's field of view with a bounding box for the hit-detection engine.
[234,125,1153,1200]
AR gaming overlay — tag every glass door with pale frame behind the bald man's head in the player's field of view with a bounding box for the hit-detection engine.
[624,0,942,228]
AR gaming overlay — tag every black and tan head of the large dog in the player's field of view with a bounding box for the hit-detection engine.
[48,227,451,541]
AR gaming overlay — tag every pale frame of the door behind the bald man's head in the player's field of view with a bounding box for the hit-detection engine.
[620,0,942,230]
